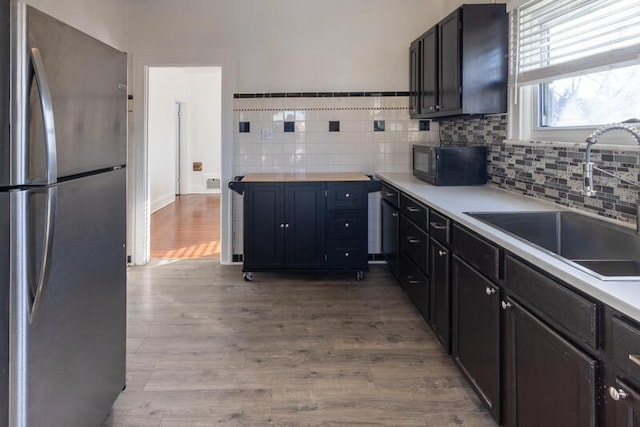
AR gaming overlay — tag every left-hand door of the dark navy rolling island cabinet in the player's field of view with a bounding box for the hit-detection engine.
[243,183,285,271]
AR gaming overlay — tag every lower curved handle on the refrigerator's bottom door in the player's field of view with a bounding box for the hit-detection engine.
[29,187,58,323]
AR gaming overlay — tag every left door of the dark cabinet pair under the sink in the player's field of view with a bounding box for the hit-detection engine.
[451,255,500,422]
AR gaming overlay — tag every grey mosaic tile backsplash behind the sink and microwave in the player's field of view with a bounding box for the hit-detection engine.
[440,115,640,226]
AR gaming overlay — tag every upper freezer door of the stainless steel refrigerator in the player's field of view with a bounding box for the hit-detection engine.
[24,7,127,183]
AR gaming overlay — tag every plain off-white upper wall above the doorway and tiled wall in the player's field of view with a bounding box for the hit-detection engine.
[129,0,442,92]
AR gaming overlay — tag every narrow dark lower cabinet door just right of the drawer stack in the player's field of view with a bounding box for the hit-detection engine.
[429,238,451,353]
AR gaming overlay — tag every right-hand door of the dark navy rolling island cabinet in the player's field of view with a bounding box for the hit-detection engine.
[285,182,327,268]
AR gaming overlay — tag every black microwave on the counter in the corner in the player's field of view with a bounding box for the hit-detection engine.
[412,145,487,185]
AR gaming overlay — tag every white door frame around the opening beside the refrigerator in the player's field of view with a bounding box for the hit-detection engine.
[127,50,235,265]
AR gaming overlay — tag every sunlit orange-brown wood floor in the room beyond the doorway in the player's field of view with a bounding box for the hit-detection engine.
[151,194,220,259]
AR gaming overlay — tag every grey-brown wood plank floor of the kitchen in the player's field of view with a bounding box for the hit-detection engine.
[104,260,495,427]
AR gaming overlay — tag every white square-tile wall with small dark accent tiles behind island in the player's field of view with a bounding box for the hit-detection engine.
[233,96,438,254]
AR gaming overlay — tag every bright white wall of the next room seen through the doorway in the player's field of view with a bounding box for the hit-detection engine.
[147,67,221,212]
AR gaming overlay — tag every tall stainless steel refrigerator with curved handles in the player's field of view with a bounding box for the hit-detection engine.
[0,0,127,427]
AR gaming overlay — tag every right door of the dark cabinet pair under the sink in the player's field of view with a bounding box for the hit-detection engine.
[503,299,598,427]
